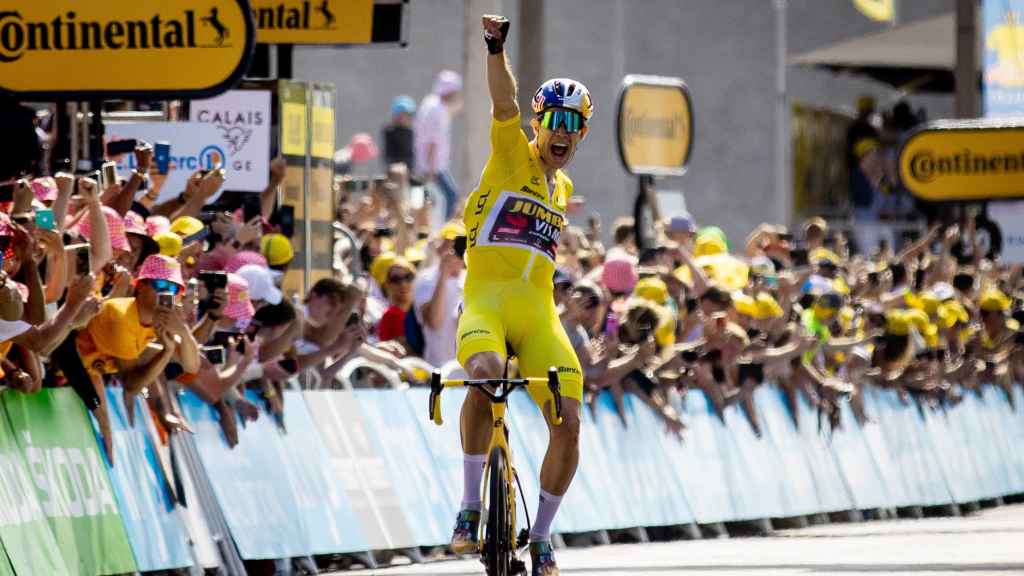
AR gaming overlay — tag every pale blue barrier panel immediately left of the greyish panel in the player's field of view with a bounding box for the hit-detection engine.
[279,390,370,554]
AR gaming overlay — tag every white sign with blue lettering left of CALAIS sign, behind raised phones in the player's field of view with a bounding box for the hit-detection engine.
[105,122,230,202]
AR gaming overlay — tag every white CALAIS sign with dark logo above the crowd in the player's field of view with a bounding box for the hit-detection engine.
[188,90,268,192]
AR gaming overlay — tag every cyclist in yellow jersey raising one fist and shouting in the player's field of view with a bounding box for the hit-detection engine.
[452,15,593,576]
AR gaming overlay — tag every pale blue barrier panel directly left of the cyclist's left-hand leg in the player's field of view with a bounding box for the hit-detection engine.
[404,387,466,525]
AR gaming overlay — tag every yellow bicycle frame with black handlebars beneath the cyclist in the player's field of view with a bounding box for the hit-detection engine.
[430,368,562,554]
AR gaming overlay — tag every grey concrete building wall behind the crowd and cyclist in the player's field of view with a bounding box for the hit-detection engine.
[295,0,953,246]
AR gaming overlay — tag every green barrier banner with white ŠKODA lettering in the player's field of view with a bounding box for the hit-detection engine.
[0,388,136,575]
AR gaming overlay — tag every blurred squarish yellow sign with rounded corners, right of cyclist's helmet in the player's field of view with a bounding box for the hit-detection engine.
[618,75,693,175]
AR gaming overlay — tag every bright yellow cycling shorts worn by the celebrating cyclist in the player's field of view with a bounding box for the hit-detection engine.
[458,279,583,401]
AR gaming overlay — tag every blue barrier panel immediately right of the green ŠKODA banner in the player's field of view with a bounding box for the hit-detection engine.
[100,387,193,572]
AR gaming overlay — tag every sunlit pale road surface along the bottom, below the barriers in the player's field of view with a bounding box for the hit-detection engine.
[342,504,1024,576]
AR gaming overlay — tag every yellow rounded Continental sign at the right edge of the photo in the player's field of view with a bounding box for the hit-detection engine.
[899,121,1024,202]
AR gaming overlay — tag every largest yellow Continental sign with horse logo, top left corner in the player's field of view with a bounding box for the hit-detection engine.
[0,0,255,99]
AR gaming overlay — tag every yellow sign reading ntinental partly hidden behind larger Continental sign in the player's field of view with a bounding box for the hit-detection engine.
[251,0,374,44]
